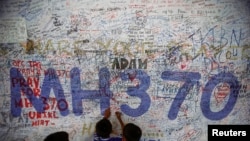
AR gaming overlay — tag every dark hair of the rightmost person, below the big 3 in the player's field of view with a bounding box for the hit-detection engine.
[123,123,142,141]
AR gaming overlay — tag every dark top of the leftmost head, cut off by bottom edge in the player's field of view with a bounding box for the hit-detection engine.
[44,131,69,141]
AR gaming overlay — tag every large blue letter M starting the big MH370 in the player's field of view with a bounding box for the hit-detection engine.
[10,68,69,117]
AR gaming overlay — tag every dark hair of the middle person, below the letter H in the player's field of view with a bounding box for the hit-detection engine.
[95,118,112,138]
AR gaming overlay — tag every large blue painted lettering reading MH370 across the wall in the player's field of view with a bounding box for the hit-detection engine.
[10,68,240,120]
